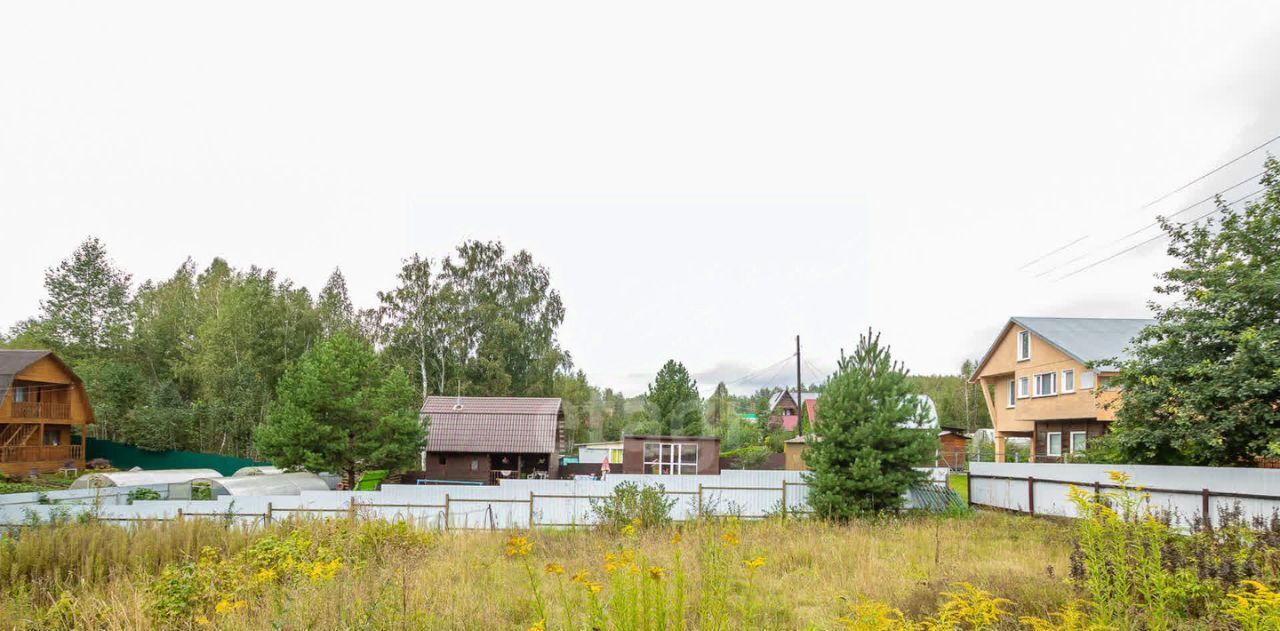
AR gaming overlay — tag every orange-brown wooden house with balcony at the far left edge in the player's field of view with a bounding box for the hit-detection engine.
[0,349,93,476]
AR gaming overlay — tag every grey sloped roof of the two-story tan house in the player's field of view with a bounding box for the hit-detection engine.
[1011,316,1156,371]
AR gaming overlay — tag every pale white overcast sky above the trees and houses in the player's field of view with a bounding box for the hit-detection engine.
[0,0,1280,394]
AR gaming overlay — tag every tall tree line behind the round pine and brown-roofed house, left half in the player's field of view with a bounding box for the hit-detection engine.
[0,238,576,456]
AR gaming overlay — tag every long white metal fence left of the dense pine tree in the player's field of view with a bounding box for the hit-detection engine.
[0,468,946,529]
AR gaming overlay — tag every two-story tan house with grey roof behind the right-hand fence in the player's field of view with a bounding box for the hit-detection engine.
[973,317,1153,462]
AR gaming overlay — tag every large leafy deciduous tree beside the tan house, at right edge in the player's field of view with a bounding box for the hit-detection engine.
[1091,159,1280,466]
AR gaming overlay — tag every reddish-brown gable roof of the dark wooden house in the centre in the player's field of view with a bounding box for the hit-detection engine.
[422,397,561,453]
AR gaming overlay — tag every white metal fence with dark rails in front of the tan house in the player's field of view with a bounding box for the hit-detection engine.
[968,462,1280,526]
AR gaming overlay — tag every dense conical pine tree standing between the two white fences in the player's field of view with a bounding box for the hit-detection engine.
[804,330,936,520]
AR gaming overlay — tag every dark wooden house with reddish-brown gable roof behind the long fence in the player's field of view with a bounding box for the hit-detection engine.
[422,397,564,484]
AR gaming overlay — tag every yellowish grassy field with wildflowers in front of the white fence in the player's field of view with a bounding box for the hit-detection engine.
[0,513,1073,630]
